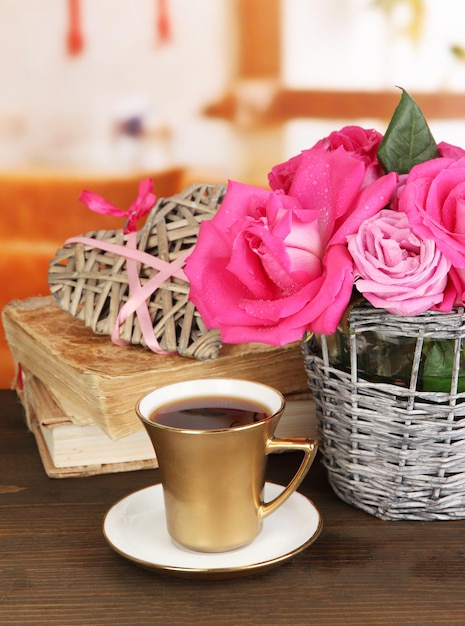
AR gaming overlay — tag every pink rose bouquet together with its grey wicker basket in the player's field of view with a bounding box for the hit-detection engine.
[182,86,465,520]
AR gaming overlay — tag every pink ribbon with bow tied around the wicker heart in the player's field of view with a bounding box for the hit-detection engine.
[65,178,190,354]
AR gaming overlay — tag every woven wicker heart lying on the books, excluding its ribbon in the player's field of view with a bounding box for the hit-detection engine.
[48,184,226,361]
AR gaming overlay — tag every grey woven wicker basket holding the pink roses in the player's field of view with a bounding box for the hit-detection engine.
[303,303,465,520]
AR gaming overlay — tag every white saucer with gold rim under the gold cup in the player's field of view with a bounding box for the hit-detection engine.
[103,483,322,578]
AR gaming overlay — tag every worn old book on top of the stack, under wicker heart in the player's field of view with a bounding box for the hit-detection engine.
[2,296,309,440]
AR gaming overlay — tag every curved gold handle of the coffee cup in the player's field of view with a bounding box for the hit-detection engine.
[259,438,318,518]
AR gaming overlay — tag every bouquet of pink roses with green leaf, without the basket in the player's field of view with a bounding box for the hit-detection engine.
[185,91,465,352]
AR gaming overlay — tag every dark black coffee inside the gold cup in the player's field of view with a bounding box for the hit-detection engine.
[150,397,270,430]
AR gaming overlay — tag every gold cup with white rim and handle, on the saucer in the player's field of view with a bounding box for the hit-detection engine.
[136,378,317,552]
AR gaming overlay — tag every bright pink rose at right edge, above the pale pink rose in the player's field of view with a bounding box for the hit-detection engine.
[398,157,465,268]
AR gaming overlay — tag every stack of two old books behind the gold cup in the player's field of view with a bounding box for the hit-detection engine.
[2,296,316,478]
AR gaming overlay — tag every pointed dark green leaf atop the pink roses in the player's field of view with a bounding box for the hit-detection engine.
[378,89,440,174]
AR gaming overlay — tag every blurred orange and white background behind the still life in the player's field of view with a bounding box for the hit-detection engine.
[0,0,465,387]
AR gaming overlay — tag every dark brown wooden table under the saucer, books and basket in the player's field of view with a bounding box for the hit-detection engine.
[0,391,465,626]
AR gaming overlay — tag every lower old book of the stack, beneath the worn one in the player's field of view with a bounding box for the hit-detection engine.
[17,370,317,478]
